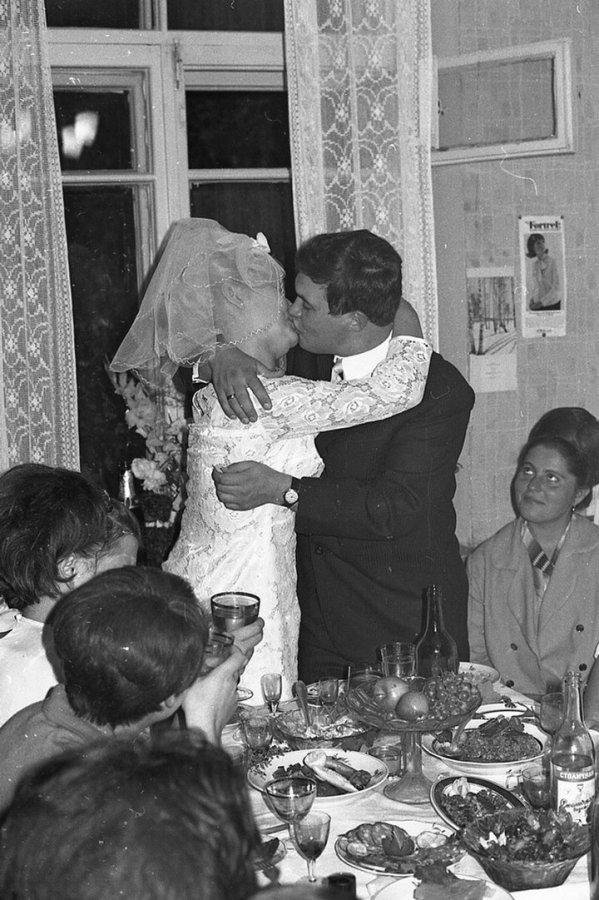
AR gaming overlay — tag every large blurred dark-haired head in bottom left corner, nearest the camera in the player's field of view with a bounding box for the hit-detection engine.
[0,731,259,900]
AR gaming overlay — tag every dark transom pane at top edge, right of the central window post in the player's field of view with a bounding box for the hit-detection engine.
[166,0,284,31]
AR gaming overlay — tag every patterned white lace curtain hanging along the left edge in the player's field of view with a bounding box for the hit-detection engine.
[0,0,79,470]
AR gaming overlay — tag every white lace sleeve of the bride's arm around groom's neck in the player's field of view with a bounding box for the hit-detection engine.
[260,336,432,438]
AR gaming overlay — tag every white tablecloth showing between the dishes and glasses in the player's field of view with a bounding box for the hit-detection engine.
[225,682,599,900]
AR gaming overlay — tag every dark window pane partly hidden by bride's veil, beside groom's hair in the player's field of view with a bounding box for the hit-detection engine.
[190,182,295,282]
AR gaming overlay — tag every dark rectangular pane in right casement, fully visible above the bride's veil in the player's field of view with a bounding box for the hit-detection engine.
[186,91,291,169]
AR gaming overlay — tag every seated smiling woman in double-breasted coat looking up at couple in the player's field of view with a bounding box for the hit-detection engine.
[467,407,599,695]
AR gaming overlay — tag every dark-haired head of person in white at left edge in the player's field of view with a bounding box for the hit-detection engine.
[0,463,134,609]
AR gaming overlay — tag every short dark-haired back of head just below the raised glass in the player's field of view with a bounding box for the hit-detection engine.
[48,566,207,728]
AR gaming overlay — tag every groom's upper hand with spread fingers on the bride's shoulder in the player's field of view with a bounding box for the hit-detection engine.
[211,345,282,425]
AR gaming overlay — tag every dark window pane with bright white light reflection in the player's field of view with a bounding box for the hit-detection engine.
[54,88,135,171]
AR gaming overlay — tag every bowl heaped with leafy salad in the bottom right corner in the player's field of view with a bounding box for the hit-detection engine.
[460,807,590,891]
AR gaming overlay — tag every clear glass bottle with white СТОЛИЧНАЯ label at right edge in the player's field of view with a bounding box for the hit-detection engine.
[549,672,595,824]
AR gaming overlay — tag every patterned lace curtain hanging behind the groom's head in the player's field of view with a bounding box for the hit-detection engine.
[285,0,437,344]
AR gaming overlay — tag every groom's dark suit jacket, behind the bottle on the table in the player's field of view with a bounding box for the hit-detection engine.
[295,353,474,681]
